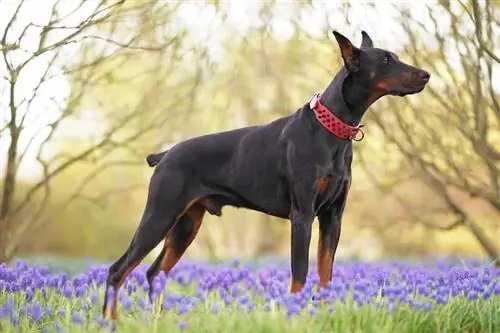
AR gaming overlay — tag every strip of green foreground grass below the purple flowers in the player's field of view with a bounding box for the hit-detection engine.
[0,284,500,333]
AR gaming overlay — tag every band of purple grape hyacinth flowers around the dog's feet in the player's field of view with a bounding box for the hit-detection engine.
[0,261,500,332]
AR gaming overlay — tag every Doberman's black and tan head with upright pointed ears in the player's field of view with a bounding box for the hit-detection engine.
[333,31,430,97]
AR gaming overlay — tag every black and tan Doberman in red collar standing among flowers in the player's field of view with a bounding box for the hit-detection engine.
[103,31,430,319]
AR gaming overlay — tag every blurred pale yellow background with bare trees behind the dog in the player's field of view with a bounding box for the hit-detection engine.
[0,0,500,263]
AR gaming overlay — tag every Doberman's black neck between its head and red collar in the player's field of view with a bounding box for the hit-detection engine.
[321,67,374,126]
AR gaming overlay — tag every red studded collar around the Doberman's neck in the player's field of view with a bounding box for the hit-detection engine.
[309,94,365,141]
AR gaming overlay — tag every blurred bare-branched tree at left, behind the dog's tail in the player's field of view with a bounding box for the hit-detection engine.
[0,0,205,262]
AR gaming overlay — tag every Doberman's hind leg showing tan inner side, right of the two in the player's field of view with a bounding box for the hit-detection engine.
[146,202,206,309]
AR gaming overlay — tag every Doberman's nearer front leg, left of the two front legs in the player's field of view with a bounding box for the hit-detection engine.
[290,210,314,293]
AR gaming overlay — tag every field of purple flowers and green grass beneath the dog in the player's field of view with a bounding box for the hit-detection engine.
[0,261,500,333]
